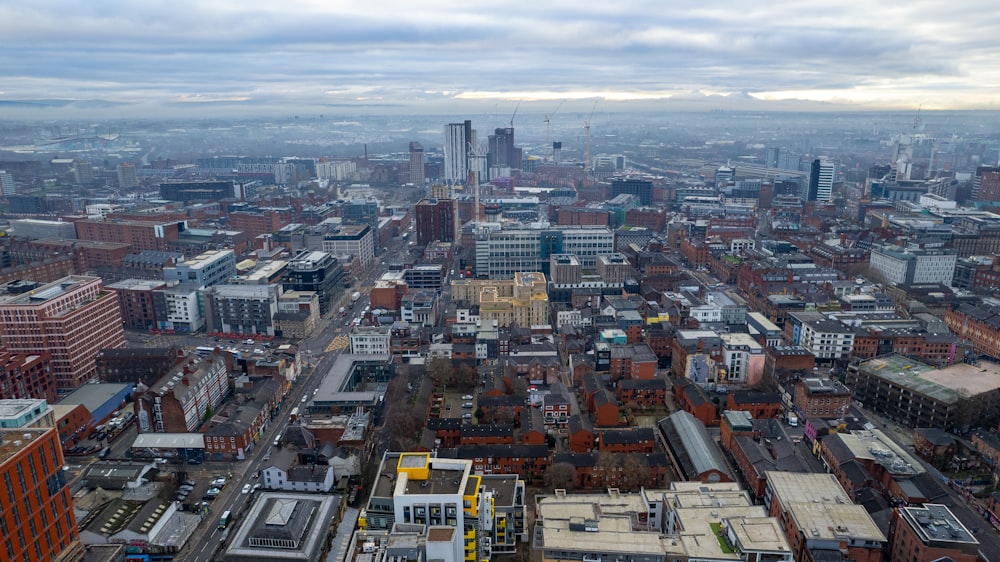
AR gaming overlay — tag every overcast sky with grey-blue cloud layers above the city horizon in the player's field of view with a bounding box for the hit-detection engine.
[0,0,1000,117]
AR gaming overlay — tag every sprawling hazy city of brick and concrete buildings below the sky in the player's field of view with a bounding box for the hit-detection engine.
[0,105,1000,562]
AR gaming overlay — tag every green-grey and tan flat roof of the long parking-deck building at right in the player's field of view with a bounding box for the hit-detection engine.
[859,355,1000,404]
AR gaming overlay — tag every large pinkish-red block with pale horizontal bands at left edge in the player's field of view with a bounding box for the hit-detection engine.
[0,275,125,391]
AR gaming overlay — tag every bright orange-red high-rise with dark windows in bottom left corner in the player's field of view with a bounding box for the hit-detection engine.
[0,427,83,562]
